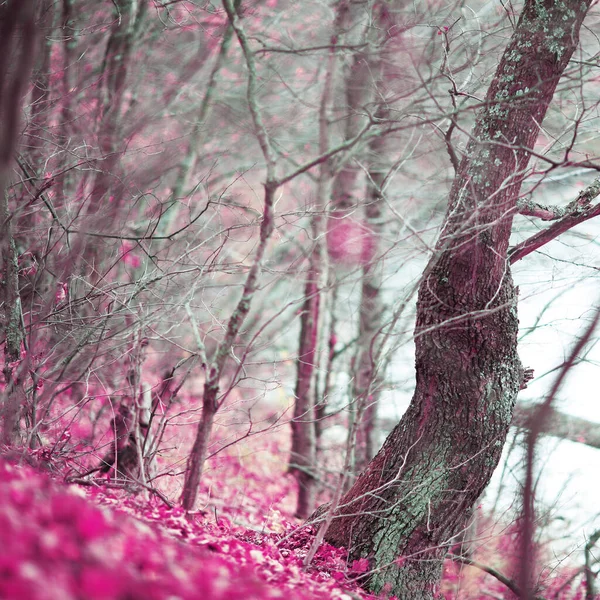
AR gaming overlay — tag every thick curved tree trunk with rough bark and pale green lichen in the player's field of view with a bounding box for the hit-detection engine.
[326,0,590,600]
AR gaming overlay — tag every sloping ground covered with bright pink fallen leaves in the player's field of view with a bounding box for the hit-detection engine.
[0,458,584,600]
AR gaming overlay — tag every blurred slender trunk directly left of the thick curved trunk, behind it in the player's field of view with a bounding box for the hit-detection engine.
[334,2,403,475]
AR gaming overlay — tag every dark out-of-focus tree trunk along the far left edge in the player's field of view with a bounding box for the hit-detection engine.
[0,0,36,444]
